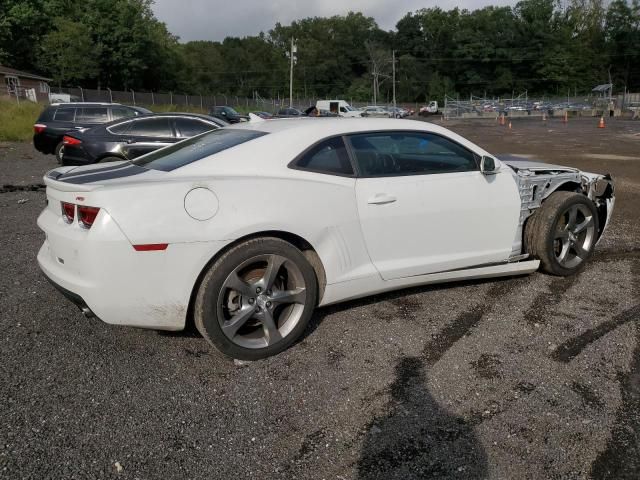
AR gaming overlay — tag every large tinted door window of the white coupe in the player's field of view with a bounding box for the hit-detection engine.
[349,132,478,177]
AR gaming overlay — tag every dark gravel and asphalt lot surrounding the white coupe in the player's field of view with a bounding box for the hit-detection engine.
[0,119,640,480]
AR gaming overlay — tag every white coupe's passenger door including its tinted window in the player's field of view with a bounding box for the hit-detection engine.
[348,132,520,280]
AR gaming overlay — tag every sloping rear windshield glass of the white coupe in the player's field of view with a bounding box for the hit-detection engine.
[131,128,267,172]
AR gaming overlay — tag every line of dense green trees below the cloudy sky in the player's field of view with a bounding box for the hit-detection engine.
[0,0,640,101]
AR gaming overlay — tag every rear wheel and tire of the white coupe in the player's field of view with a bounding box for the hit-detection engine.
[194,237,318,360]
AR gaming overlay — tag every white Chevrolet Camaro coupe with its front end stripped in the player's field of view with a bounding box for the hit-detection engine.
[38,119,614,359]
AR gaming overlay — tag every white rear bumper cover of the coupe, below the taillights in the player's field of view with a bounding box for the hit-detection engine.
[38,201,229,330]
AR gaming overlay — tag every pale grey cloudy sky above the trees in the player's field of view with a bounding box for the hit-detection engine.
[153,0,515,41]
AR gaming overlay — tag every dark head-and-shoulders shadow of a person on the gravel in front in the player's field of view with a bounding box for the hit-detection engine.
[357,357,487,480]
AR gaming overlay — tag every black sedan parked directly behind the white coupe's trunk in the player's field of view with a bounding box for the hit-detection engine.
[61,113,228,165]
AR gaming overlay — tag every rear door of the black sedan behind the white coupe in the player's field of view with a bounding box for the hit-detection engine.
[122,116,176,160]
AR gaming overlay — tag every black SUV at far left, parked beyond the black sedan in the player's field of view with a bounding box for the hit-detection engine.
[33,102,152,161]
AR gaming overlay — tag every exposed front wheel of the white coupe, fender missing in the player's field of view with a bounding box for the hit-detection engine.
[524,192,599,276]
